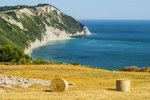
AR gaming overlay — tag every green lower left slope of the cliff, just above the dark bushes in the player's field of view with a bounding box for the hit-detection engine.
[0,17,28,51]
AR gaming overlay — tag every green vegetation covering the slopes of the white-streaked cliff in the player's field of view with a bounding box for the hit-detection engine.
[0,4,84,51]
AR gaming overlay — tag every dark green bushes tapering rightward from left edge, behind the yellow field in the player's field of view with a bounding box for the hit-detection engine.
[0,45,80,65]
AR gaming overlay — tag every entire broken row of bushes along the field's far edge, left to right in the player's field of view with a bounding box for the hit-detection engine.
[0,45,150,72]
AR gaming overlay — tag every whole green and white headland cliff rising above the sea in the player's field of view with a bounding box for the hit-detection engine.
[0,4,90,54]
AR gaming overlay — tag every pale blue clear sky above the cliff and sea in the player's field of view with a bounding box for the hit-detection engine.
[0,0,150,20]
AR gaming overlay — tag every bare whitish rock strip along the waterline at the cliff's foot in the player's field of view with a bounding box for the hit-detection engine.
[24,26,91,56]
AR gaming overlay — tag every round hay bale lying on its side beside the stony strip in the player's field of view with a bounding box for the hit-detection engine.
[50,78,69,92]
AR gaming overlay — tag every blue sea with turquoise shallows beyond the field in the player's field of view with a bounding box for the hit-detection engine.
[30,20,150,70]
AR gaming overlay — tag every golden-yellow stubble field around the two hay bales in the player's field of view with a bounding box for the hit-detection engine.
[0,65,150,100]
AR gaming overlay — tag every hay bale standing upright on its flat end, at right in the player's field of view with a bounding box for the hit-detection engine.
[116,80,130,92]
